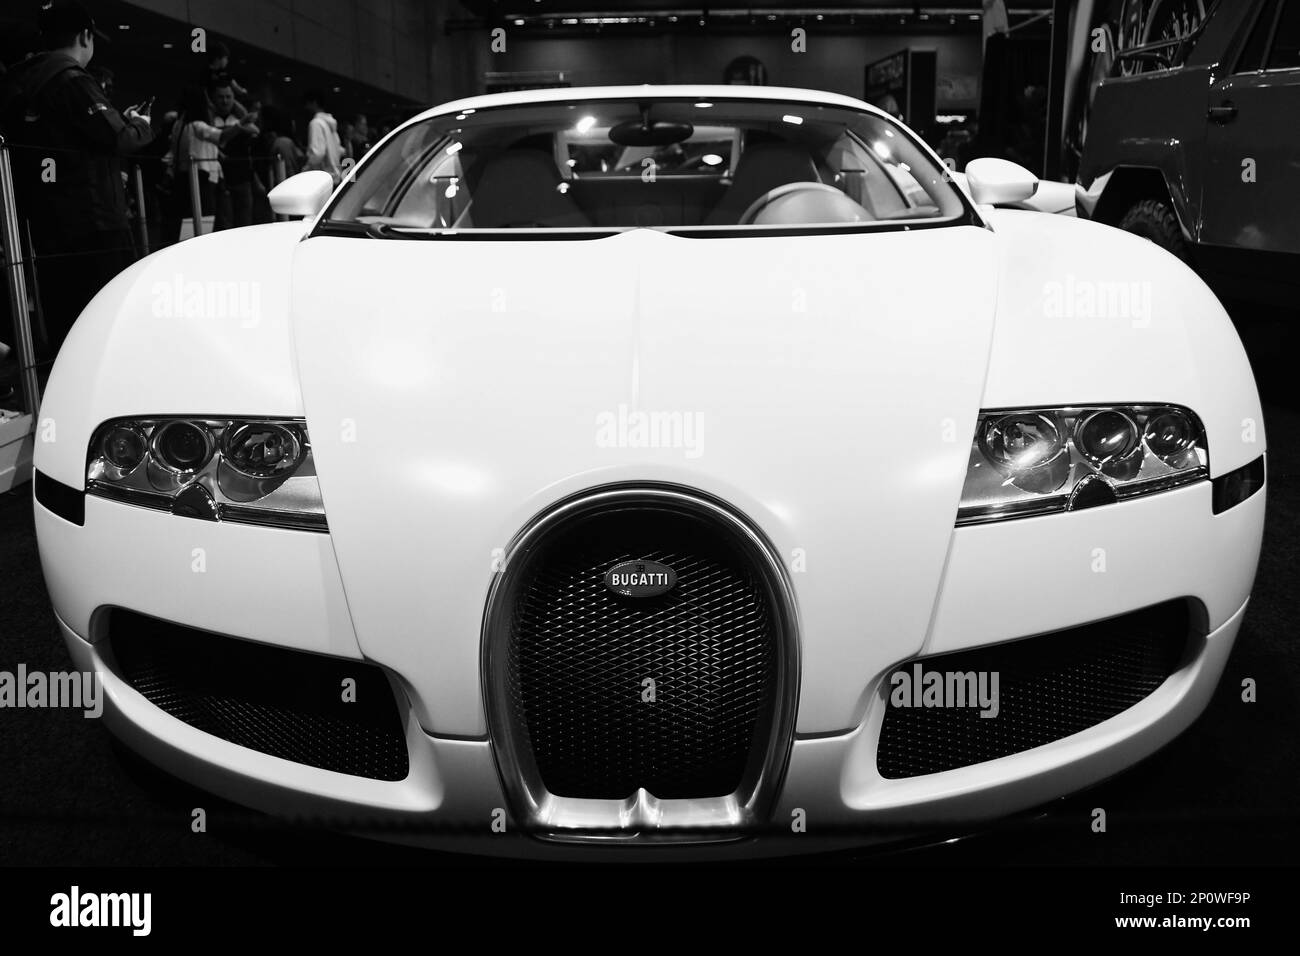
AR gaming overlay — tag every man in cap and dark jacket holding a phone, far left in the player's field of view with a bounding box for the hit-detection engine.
[0,0,153,359]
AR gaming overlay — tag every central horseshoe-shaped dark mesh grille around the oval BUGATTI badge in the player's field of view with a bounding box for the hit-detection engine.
[504,507,781,800]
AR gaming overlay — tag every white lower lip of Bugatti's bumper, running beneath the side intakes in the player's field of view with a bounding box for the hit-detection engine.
[60,605,1245,856]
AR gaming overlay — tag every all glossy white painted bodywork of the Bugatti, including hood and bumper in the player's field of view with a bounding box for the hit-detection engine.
[35,87,1265,849]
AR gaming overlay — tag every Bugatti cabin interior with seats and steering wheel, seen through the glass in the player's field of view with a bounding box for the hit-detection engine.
[335,104,940,230]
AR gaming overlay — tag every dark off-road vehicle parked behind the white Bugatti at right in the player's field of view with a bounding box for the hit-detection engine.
[1078,0,1300,303]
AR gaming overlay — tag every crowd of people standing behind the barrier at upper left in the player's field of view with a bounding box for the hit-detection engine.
[0,0,387,399]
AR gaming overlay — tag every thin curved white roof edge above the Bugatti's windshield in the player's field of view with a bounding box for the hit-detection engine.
[402,83,887,126]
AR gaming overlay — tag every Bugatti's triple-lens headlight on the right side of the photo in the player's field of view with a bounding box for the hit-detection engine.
[957,405,1209,525]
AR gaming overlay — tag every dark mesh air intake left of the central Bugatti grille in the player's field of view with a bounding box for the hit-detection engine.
[108,610,408,780]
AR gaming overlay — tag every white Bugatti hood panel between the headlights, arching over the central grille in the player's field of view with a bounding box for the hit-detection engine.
[291,226,998,736]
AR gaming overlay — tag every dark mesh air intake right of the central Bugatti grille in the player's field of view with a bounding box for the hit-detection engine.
[876,601,1190,778]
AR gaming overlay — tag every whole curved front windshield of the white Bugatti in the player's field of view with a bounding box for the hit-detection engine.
[322,98,969,235]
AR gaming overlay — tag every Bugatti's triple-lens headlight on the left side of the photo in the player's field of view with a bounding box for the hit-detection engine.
[86,418,328,531]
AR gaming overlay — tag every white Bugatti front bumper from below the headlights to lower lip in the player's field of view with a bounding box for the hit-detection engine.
[36,483,1265,856]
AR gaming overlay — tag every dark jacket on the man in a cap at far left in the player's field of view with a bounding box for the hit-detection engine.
[0,53,153,246]
